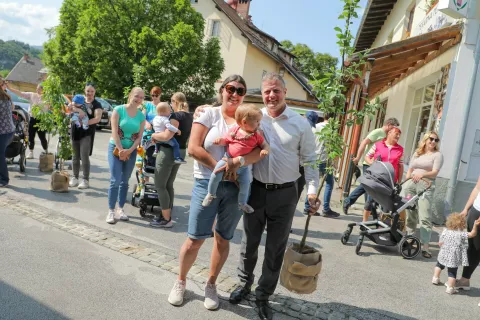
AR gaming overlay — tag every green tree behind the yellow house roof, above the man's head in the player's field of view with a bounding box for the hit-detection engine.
[280,40,338,79]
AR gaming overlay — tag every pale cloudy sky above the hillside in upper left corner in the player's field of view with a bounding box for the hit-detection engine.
[0,0,60,45]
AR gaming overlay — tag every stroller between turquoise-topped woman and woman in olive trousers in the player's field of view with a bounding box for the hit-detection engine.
[131,135,160,217]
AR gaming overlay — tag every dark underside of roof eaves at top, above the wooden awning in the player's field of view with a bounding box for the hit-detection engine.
[354,0,398,51]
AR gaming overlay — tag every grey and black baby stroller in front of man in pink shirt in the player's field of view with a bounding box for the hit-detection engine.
[341,161,431,259]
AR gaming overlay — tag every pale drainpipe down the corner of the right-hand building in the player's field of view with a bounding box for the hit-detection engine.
[444,21,480,216]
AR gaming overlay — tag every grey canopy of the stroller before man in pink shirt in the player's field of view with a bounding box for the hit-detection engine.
[359,161,395,211]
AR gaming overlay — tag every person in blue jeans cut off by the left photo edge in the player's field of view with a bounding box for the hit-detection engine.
[0,77,15,188]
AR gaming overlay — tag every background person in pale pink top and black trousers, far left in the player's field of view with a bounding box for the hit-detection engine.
[7,83,48,159]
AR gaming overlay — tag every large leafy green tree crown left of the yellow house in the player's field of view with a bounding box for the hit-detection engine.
[45,0,224,100]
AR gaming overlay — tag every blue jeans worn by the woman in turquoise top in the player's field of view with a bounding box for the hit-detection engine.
[108,143,137,209]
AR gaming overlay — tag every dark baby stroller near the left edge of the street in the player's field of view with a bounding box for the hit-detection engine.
[5,106,30,172]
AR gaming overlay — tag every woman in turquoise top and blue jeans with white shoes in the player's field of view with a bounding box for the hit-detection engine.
[106,87,145,224]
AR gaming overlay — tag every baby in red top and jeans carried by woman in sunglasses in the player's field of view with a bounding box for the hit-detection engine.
[202,104,270,213]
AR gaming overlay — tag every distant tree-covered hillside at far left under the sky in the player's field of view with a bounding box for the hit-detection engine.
[0,40,41,70]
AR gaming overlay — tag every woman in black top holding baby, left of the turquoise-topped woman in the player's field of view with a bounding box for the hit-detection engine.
[69,83,103,189]
